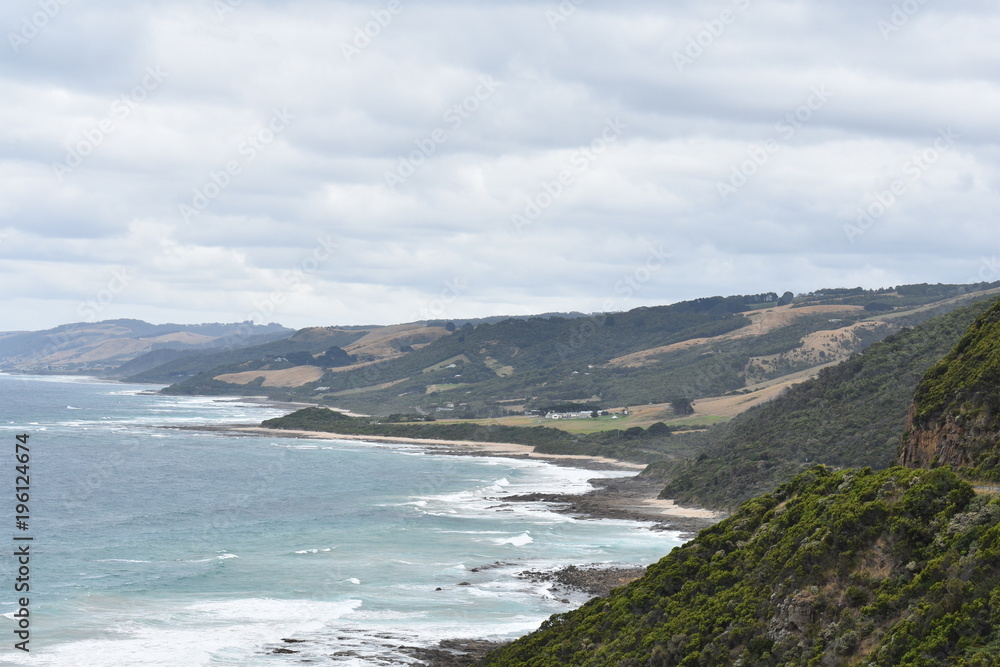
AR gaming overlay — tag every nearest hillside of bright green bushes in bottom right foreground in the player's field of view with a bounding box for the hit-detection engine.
[482,466,1000,667]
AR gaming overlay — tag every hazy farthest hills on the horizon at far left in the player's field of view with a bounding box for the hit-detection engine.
[0,319,292,374]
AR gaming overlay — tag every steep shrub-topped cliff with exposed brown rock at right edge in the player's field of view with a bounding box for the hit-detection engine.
[899,302,1000,480]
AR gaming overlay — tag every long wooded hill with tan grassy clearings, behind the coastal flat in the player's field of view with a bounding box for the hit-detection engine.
[152,283,1000,418]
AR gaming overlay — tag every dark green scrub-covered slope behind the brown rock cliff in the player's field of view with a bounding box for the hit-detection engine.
[647,301,990,508]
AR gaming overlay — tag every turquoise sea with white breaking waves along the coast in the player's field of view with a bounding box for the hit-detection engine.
[0,375,680,666]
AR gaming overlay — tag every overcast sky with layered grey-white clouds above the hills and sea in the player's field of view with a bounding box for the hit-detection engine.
[0,0,1000,330]
